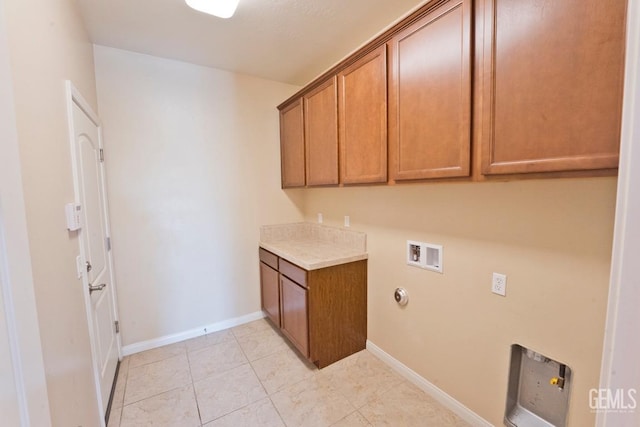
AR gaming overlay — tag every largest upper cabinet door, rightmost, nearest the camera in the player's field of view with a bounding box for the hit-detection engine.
[482,0,627,174]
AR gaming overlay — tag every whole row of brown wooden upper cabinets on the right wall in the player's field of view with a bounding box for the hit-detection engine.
[280,0,627,187]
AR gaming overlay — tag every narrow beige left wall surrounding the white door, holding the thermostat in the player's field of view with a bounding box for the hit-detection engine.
[5,0,100,426]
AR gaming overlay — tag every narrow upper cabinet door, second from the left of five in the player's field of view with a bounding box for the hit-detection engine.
[304,77,338,186]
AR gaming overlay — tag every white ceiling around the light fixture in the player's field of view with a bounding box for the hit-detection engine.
[76,0,425,85]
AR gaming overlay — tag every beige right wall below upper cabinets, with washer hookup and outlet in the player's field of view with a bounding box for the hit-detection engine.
[305,178,616,427]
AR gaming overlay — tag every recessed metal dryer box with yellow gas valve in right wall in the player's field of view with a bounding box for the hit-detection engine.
[504,344,571,427]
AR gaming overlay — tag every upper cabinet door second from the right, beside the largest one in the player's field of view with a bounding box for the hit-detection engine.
[389,0,472,181]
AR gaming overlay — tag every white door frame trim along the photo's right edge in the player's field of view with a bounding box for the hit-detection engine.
[596,0,640,427]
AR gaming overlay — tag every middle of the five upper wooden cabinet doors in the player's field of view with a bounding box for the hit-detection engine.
[338,46,387,184]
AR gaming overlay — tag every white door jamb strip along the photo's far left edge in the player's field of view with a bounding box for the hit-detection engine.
[0,0,51,427]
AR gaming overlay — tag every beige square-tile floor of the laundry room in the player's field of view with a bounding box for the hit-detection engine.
[109,320,468,427]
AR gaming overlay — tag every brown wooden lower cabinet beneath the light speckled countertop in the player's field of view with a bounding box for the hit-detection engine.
[260,248,367,368]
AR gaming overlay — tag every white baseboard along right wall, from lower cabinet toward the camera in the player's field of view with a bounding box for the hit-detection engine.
[367,340,493,427]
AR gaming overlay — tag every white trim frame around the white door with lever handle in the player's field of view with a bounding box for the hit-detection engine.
[65,80,122,427]
